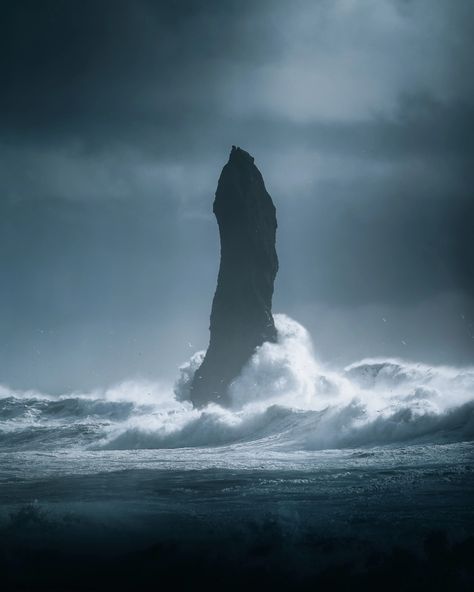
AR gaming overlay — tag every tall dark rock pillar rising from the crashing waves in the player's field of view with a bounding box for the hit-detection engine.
[191,146,278,406]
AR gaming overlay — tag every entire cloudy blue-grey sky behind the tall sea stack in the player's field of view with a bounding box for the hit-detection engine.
[0,0,474,392]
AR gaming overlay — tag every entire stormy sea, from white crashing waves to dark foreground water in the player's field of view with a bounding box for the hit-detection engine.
[0,315,474,590]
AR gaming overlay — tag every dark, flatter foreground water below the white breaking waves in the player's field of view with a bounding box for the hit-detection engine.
[0,443,474,590]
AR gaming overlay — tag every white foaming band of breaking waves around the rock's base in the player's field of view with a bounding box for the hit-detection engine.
[0,315,474,450]
